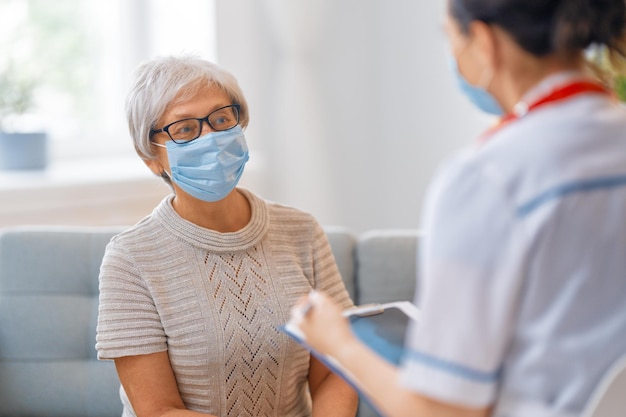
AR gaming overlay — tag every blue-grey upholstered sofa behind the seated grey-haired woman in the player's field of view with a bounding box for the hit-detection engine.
[0,227,418,417]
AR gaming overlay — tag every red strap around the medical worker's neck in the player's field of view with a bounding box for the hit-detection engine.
[480,81,610,142]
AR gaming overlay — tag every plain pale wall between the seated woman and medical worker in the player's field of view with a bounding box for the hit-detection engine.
[217,0,489,232]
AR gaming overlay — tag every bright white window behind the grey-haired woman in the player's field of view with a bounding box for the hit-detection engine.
[0,0,216,162]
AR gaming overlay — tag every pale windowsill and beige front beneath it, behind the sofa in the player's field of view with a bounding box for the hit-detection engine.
[0,156,170,227]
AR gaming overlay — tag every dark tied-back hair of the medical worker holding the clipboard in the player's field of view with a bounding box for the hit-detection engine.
[449,0,626,58]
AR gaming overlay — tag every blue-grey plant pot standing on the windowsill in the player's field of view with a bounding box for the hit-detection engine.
[0,132,48,170]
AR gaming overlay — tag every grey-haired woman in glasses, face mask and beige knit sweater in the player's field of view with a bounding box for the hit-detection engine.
[96,56,357,417]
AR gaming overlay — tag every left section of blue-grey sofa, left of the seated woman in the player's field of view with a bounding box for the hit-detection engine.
[0,227,122,417]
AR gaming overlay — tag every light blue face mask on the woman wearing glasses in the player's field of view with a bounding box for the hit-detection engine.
[165,125,249,202]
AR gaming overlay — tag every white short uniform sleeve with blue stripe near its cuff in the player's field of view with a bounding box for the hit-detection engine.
[400,150,524,407]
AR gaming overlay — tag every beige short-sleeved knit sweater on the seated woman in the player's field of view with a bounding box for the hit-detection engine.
[96,189,352,417]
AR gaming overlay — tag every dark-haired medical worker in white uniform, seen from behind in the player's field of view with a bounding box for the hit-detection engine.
[292,0,626,417]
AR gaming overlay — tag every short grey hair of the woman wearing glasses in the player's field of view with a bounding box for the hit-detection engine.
[126,55,249,159]
